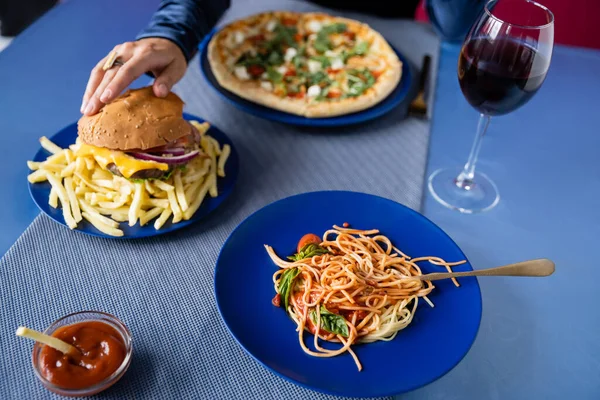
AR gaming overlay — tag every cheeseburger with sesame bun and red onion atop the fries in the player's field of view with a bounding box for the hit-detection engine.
[77,87,206,180]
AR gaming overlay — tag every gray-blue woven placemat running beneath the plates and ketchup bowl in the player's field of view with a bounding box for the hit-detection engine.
[0,1,438,399]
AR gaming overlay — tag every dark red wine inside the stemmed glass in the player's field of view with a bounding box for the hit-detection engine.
[458,37,549,115]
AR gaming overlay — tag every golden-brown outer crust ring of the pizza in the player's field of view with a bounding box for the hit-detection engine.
[208,11,402,118]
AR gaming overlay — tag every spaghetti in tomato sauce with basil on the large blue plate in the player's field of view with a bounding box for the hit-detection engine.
[265,224,466,371]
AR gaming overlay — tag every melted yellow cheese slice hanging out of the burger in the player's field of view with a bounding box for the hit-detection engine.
[75,143,169,178]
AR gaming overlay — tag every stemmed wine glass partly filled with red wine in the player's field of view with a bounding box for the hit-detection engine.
[428,0,554,214]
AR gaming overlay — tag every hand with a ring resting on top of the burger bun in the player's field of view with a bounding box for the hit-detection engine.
[81,38,187,115]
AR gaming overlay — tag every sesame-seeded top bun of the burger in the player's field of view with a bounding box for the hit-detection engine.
[77,86,191,151]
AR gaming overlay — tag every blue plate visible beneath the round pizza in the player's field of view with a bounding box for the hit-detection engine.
[199,30,412,127]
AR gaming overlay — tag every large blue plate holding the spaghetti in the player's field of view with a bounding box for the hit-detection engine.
[215,191,481,397]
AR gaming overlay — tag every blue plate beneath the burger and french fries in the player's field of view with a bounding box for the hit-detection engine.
[29,113,239,239]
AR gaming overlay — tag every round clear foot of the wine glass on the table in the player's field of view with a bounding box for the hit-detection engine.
[427,167,500,214]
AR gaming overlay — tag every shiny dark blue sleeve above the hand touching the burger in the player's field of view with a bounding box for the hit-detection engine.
[136,0,231,61]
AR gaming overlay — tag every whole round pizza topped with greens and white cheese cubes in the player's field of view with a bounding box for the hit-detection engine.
[208,11,402,118]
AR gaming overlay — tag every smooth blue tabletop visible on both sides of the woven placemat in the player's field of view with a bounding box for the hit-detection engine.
[0,0,600,399]
